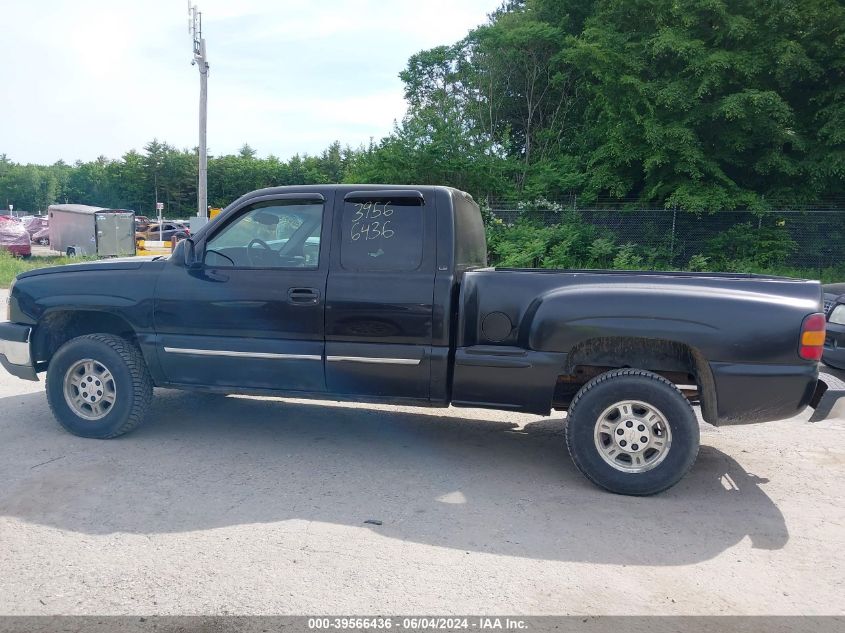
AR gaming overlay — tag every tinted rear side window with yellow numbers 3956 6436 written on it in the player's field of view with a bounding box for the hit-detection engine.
[340,198,425,271]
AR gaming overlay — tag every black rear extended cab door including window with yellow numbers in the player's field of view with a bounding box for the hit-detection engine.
[326,189,436,400]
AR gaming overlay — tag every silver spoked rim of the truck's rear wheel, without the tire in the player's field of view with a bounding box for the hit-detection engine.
[594,400,672,473]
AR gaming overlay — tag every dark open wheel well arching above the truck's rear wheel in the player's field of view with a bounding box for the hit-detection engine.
[553,337,716,420]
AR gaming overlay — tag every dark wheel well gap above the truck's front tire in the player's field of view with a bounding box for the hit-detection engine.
[32,310,137,364]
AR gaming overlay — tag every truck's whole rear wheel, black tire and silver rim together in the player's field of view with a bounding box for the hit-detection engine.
[566,369,699,495]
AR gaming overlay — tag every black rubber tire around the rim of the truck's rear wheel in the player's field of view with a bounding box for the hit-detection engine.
[566,369,700,496]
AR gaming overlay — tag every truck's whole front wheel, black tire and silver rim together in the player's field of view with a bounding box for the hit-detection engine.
[46,334,153,439]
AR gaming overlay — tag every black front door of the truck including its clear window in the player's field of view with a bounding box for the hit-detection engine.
[155,192,333,392]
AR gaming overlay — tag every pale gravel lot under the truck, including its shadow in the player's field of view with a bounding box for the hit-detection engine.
[0,288,845,615]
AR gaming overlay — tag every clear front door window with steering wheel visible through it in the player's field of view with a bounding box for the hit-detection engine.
[205,201,323,268]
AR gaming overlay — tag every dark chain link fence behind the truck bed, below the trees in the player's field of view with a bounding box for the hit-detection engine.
[490,201,845,270]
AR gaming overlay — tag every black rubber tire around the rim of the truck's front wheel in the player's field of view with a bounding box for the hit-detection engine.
[46,334,153,439]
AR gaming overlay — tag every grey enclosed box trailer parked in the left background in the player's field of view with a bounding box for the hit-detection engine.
[48,204,135,257]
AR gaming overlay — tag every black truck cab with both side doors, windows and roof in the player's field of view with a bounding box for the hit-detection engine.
[149,186,486,405]
